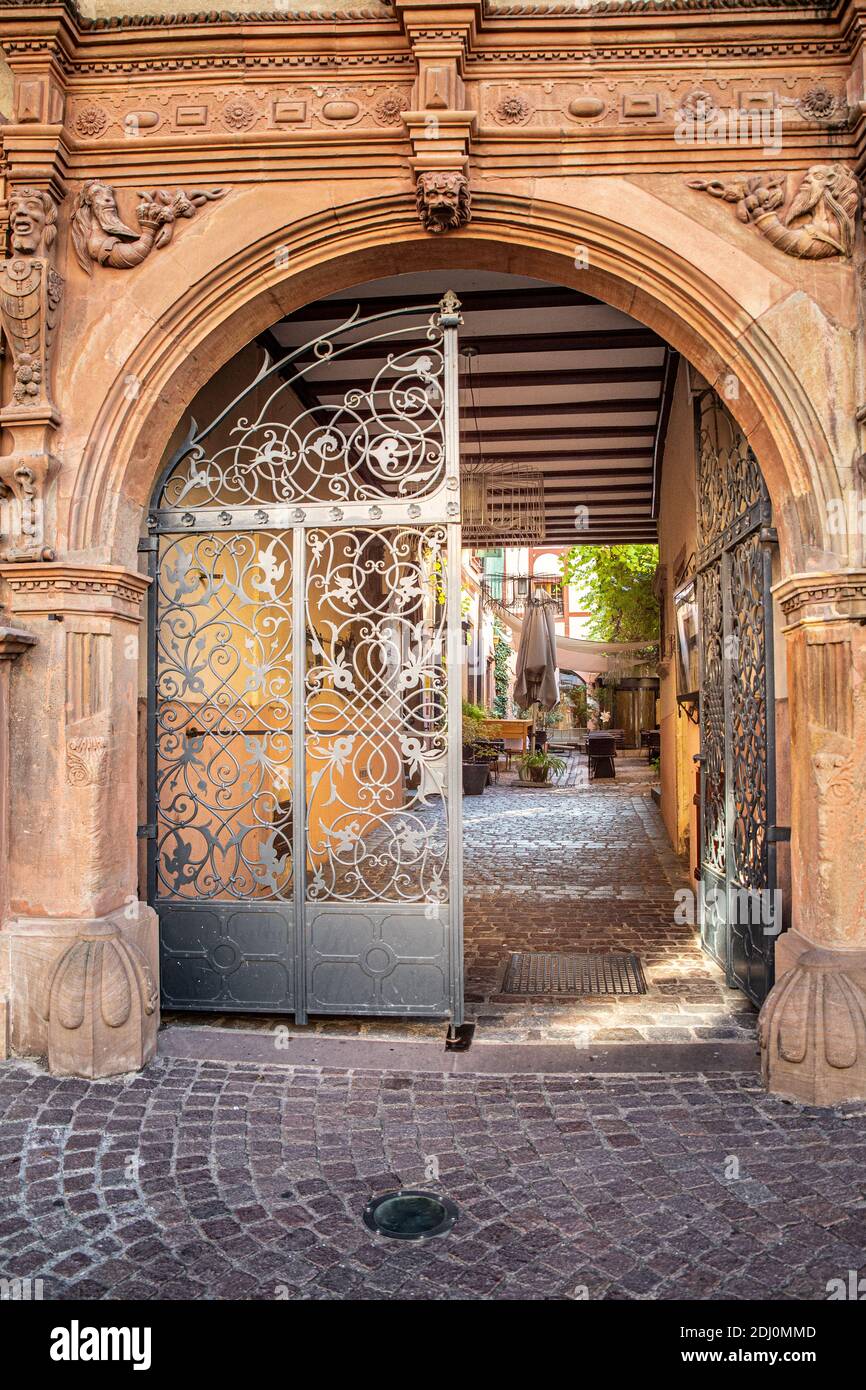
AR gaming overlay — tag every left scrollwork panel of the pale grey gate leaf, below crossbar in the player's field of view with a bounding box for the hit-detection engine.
[150,531,295,1011]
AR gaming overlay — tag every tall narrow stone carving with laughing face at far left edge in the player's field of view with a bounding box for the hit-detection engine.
[0,185,63,560]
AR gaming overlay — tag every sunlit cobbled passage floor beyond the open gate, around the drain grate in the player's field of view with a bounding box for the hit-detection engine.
[463,753,756,1043]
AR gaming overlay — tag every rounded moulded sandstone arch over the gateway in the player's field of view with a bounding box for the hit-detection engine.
[66,189,858,573]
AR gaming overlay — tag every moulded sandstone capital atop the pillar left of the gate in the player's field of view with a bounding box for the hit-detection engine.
[0,562,150,623]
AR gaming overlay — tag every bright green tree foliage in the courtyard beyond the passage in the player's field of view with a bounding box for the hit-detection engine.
[562,545,659,642]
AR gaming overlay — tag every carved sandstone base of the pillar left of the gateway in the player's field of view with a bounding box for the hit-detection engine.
[0,904,160,1077]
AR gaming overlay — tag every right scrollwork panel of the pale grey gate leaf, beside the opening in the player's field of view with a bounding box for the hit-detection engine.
[304,524,458,1013]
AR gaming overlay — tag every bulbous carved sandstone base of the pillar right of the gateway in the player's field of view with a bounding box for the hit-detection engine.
[758,933,866,1105]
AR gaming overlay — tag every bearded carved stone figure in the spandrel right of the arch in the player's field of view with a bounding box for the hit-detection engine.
[688,164,860,260]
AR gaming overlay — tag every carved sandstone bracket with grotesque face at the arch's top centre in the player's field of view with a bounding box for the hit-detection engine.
[398,0,480,232]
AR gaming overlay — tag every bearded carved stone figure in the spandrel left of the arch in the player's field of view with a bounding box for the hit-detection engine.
[72,178,227,275]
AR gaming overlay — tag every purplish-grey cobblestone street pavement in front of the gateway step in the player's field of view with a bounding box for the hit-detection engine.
[0,1059,866,1300]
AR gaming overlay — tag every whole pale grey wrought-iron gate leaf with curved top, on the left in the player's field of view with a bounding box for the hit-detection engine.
[142,292,463,1023]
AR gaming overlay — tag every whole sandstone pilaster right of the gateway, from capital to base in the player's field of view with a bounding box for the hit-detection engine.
[759,570,866,1105]
